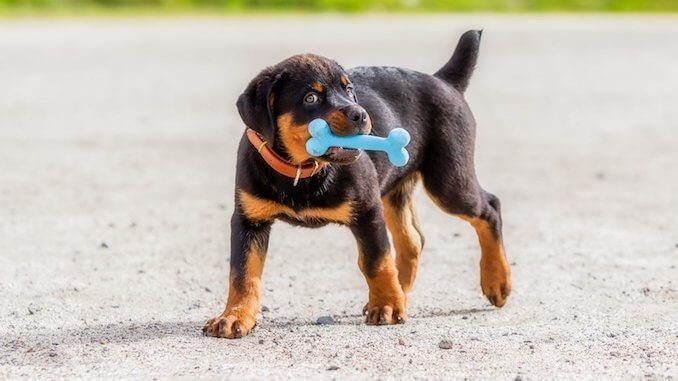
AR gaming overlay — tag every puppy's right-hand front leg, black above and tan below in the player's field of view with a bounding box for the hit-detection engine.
[351,205,406,325]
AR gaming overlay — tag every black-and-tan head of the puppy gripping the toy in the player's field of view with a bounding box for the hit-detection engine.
[237,54,372,164]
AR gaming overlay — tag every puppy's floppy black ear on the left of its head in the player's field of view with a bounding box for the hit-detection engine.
[237,71,284,146]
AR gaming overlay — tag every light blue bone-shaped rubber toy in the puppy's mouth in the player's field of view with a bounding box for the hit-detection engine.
[306,119,410,167]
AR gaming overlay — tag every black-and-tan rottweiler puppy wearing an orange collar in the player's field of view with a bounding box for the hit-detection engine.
[203,31,511,338]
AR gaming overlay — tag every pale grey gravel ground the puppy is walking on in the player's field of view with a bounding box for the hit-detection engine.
[0,16,678,380]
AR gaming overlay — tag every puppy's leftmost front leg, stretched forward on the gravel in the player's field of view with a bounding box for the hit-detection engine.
[202,208,271,339]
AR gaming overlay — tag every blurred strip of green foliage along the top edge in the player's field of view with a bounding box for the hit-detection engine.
[0,0,678,12]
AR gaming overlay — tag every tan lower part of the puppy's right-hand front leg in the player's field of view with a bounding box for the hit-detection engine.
[358,252,407,325]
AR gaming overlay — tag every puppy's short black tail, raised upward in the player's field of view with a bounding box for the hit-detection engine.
[434,30,483,93]
